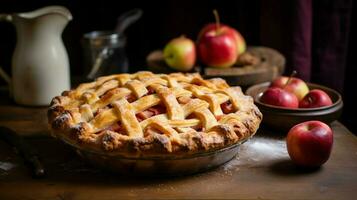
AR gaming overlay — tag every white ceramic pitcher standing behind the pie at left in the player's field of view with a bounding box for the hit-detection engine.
[0,6,72,106]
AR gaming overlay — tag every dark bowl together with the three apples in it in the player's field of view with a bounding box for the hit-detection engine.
[246,76,343,131]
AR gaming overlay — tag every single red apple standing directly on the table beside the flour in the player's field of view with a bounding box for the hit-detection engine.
[286,121,333,167]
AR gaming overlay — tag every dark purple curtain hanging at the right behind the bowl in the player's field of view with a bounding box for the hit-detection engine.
[292,0,352,92]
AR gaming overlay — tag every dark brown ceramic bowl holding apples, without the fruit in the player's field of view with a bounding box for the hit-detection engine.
[246,82,343,131]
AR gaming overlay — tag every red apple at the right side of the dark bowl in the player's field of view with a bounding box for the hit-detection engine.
[299,89,332,108]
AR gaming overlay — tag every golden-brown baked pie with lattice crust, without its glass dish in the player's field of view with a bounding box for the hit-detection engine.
[48,71,262,158]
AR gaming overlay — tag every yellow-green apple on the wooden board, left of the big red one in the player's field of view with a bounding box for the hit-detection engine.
[164,36,196,71]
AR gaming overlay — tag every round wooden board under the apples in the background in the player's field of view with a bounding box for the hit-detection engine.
[147,46,285,88]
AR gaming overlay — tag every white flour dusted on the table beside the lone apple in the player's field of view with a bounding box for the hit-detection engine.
[223,137,289,170]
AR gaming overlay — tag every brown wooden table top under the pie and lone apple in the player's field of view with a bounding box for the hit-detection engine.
[0,97,357,200]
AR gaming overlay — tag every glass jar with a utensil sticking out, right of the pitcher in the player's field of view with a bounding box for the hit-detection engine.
[83,9,143,79]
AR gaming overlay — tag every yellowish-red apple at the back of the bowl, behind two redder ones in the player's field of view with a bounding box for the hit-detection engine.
[270,76,309,101]
